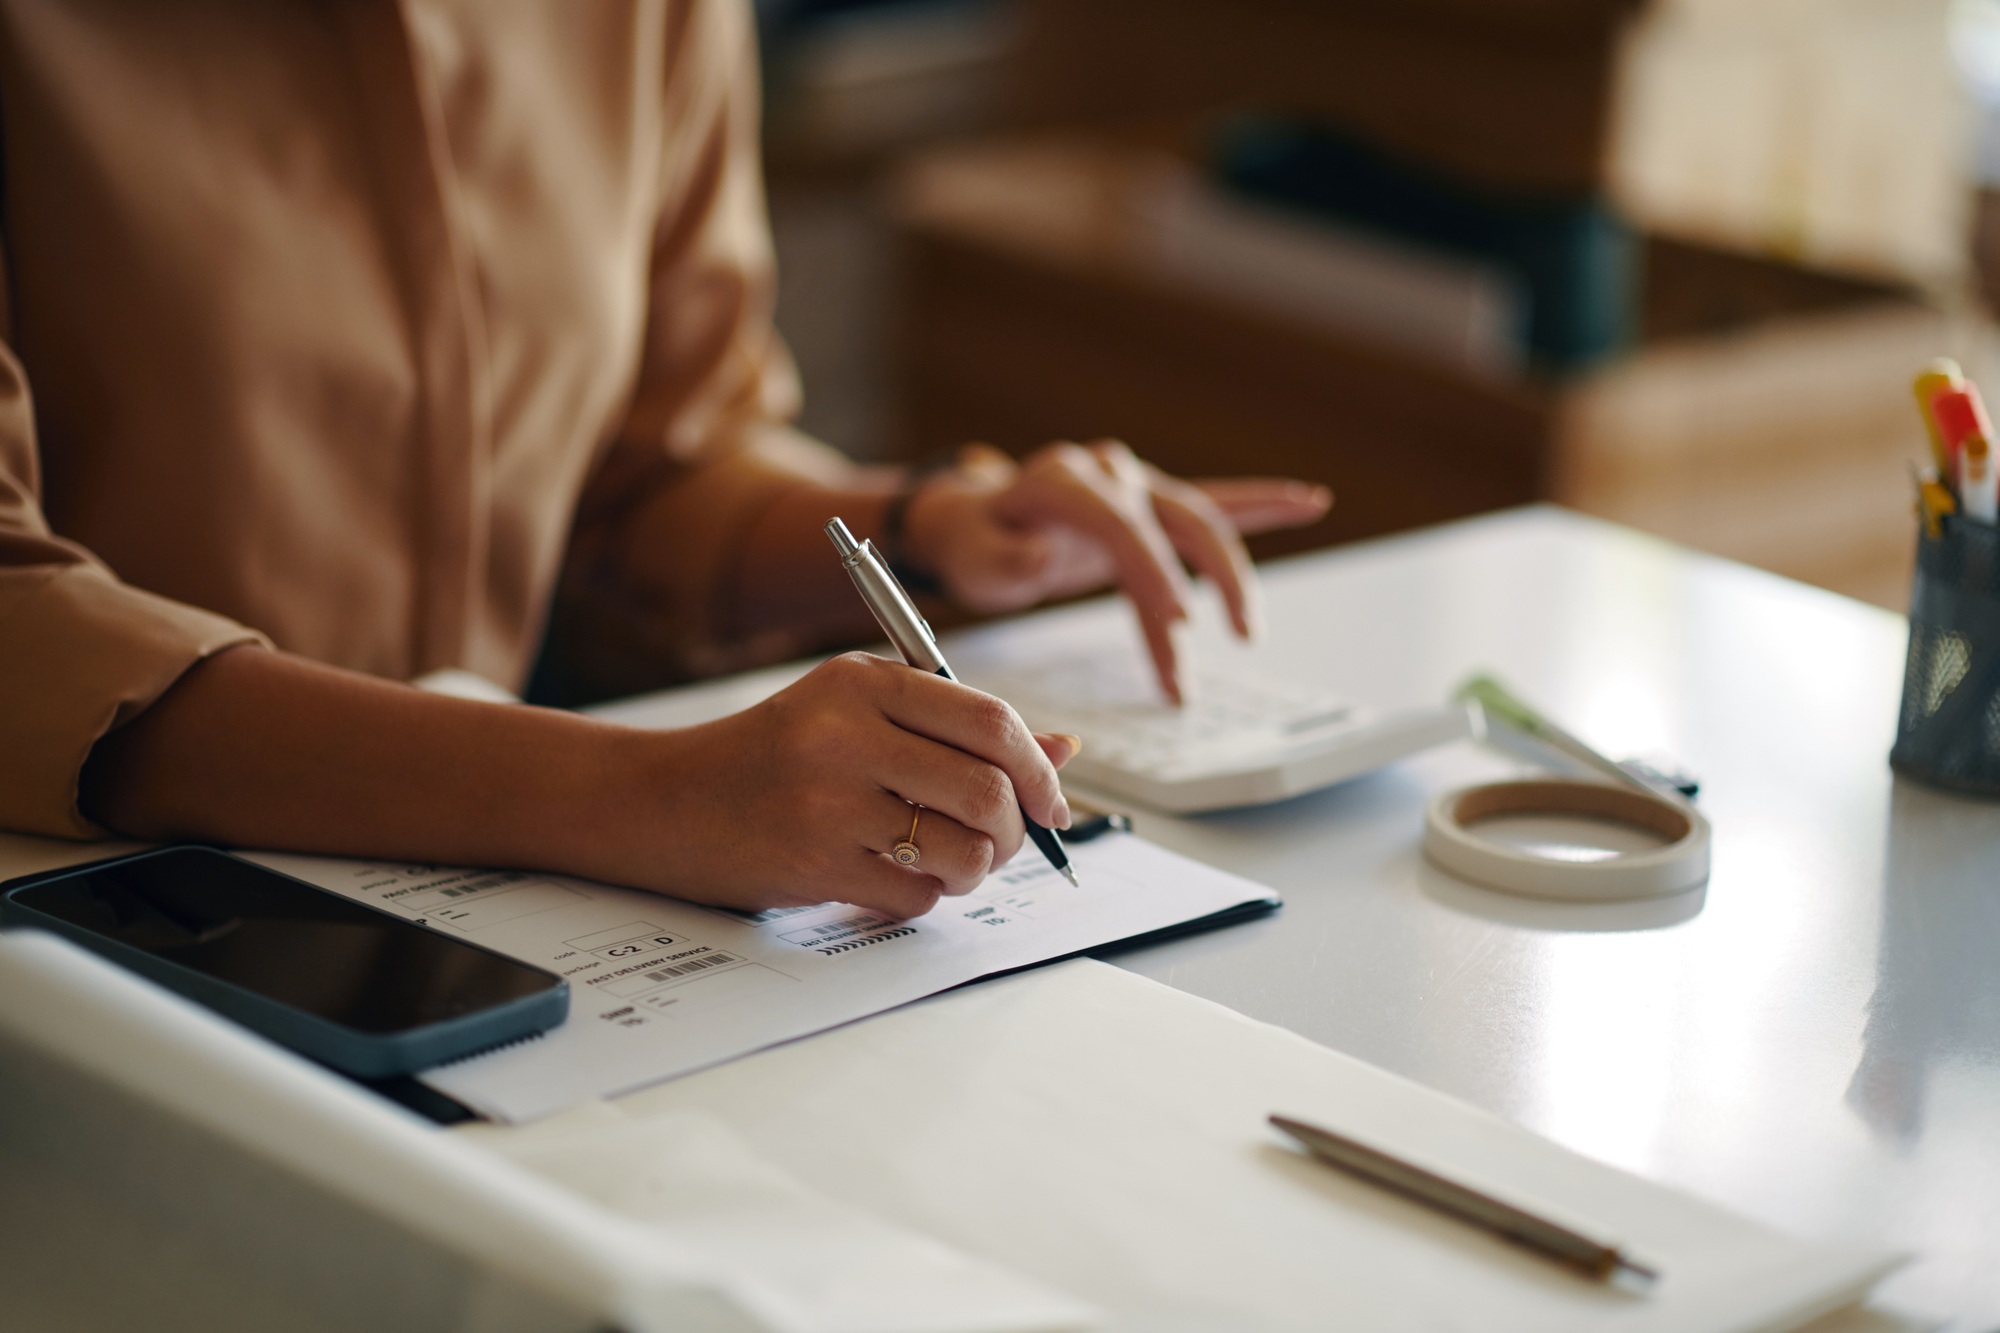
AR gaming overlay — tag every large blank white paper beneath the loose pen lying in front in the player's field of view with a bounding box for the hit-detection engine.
[596,961,1896,1333]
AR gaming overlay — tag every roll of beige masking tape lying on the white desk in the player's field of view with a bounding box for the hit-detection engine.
[1424,779,1708,901]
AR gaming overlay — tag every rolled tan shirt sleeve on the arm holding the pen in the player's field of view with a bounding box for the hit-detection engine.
[0,286,262,839]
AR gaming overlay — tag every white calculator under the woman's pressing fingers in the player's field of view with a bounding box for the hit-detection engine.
[972,658,1470,815]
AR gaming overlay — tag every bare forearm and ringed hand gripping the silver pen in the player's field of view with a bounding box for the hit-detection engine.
[84,632,1074,915]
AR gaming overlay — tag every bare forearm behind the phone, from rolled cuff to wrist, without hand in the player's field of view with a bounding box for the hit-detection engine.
[82,646,642,873]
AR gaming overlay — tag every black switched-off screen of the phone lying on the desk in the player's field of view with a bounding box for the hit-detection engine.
[10,847,562,1035]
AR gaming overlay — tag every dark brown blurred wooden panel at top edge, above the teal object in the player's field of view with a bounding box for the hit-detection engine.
[1014,0,1644,192]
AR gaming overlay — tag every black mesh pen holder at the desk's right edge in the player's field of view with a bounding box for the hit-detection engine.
[1888,518,2000,797]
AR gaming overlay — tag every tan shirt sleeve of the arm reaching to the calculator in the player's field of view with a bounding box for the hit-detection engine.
[544,0,854,695]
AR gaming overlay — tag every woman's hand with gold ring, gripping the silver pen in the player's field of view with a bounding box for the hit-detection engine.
[632,652,1078,919]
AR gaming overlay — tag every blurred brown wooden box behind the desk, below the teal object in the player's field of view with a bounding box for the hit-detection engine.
[892,138,1936,604]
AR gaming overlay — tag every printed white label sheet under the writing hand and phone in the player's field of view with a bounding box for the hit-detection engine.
[254,835,1272,1121]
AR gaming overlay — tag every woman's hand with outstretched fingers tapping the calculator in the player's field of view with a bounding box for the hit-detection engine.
[904,440,1334,705]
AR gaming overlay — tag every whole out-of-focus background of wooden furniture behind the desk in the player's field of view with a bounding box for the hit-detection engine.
[758,0,2000,610]
